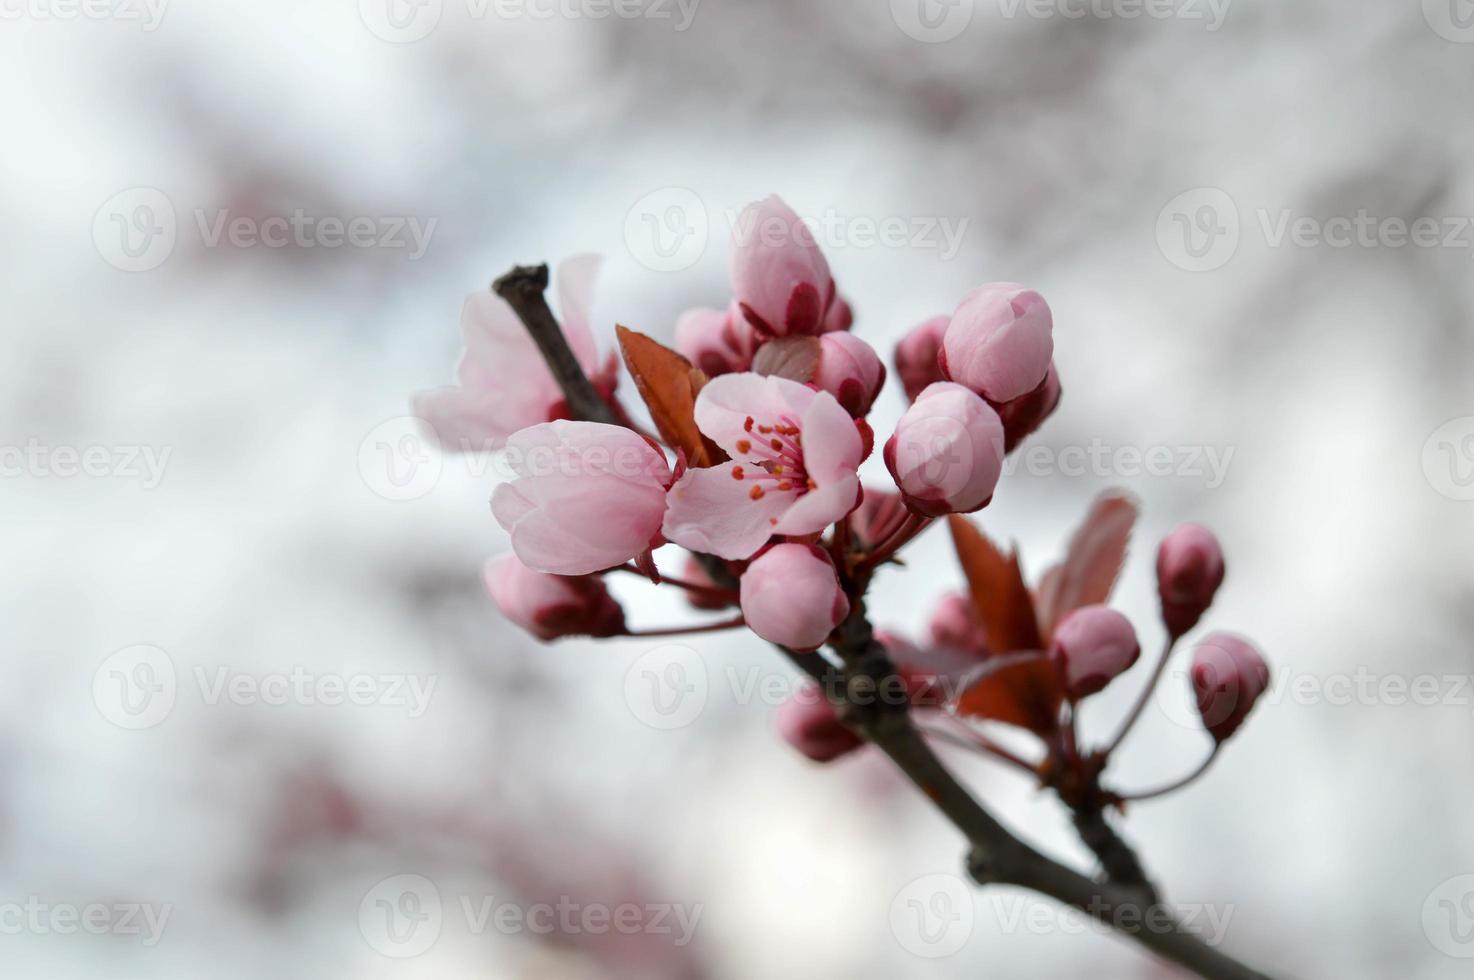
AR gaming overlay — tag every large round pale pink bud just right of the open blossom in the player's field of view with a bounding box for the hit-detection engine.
[884,382,1004,517]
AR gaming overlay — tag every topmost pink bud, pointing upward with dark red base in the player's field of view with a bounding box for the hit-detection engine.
[731,195,834,337]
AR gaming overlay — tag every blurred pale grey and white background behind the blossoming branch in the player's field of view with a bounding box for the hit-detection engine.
[0,0,1474,980]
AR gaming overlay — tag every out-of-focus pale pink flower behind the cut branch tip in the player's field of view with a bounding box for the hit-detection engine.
[414,255,619,452]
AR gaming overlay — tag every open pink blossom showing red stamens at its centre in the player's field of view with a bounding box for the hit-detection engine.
[665,374,864,560]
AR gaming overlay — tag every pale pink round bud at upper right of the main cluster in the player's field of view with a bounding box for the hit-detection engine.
[942,283,1054,404]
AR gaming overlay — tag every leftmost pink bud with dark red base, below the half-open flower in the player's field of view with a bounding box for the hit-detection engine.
[482,554,625,641]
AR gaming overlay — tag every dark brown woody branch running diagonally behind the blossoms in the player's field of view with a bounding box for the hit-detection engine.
[492,265,1269,980]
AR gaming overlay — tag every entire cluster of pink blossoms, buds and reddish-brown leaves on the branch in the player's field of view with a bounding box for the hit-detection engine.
[417,197,1268,781]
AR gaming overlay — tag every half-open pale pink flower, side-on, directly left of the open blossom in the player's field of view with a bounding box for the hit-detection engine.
[491,421,671,575]
